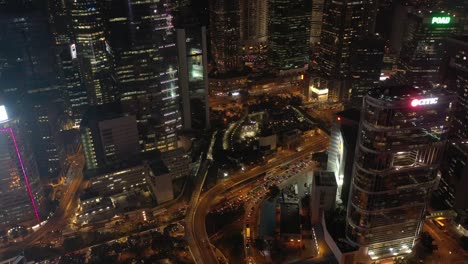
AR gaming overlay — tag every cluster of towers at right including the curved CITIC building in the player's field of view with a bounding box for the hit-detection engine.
[320,37,468,263]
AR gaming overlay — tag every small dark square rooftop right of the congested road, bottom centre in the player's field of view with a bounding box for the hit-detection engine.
[280,203,301,234]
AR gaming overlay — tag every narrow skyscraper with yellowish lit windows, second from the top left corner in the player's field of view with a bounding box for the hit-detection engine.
[69,0,115,105]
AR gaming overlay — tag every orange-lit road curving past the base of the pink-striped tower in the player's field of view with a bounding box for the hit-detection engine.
[0,154,85,254]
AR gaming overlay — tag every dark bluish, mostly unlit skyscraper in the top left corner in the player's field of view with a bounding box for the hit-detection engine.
[0,1,56,103]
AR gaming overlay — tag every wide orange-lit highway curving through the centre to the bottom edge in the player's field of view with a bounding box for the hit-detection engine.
[187,135,328,264]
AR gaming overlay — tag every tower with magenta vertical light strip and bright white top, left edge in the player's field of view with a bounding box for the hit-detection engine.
[0,105,43,229]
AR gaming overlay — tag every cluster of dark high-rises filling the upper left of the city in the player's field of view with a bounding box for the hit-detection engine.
[0,0,209,229]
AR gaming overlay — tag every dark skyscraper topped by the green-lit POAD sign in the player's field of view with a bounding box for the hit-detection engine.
[400,9,460,87]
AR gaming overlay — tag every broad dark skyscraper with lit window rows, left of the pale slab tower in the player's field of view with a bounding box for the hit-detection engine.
[105,0,182,151]
